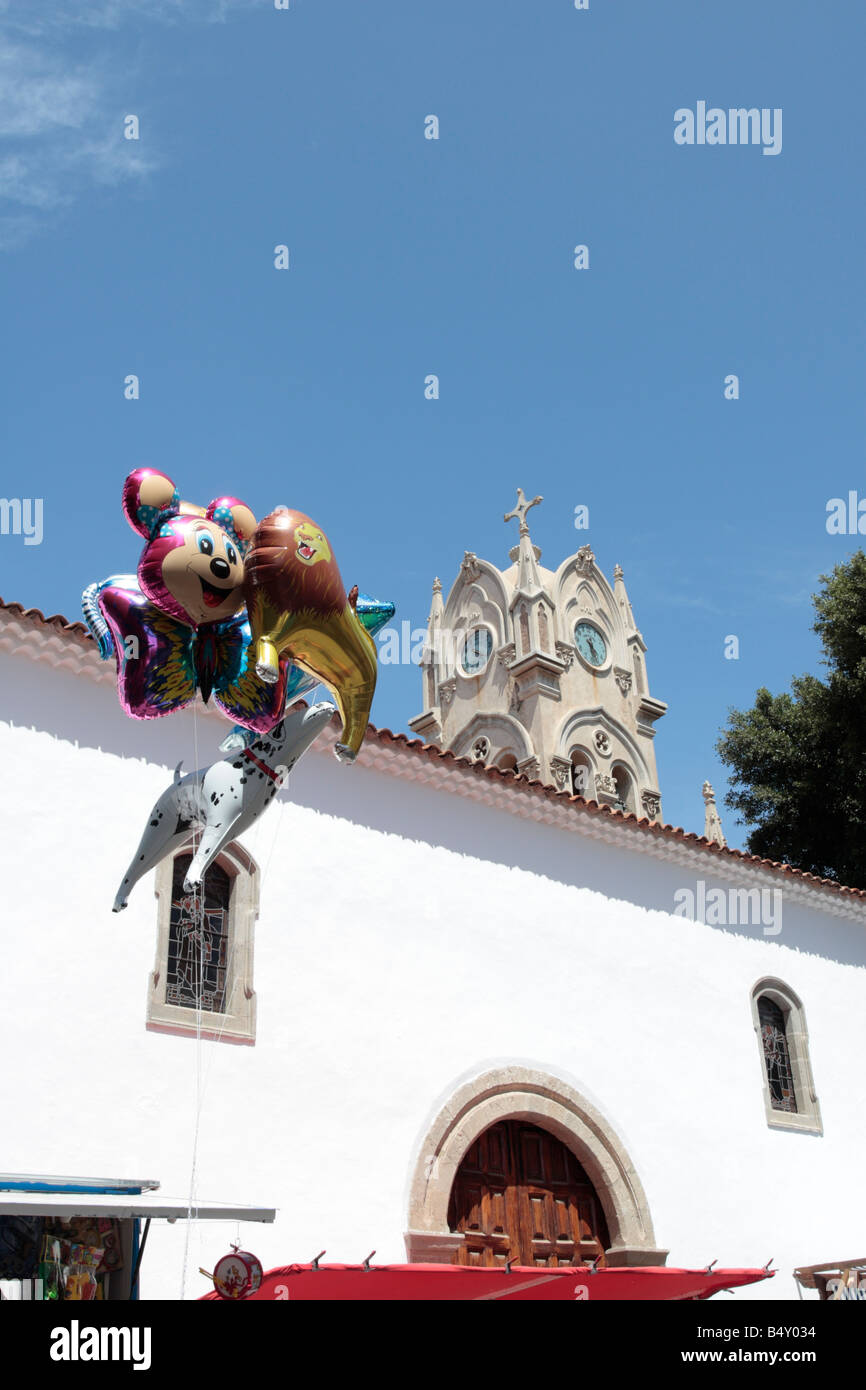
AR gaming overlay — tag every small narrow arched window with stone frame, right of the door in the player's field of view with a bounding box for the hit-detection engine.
[752,980,823,1134]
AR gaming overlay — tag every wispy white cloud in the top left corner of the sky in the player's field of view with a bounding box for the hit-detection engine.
[0,0,256,250]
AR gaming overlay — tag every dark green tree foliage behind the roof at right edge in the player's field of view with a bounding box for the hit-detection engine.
[716,550,866,888]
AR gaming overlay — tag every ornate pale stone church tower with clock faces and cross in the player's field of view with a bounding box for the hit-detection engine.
[409,488,667,820]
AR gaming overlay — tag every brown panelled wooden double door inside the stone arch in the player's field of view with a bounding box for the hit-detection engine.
[449,1120,610,1266]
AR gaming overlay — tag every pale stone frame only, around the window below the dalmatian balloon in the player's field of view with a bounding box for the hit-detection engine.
[145,841,261,1047]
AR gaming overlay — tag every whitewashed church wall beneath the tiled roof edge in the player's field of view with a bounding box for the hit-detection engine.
[0,642,866,1298]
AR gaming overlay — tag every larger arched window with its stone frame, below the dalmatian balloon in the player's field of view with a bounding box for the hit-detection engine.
[147,842,259,1043]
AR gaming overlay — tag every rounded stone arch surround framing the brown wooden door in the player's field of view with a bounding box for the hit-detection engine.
[405,1066,667,1265]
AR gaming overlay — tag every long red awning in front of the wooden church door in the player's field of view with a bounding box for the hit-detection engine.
[203,1265,773,1302]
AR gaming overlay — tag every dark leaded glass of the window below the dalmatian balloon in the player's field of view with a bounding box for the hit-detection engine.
[165,855,232,1013]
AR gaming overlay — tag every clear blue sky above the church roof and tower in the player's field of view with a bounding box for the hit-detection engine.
[0,0,866,844]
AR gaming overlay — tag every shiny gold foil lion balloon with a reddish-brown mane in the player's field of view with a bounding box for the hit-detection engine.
[243,507,378,763]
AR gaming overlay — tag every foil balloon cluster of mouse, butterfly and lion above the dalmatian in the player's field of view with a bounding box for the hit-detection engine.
[82,468,395,762]
